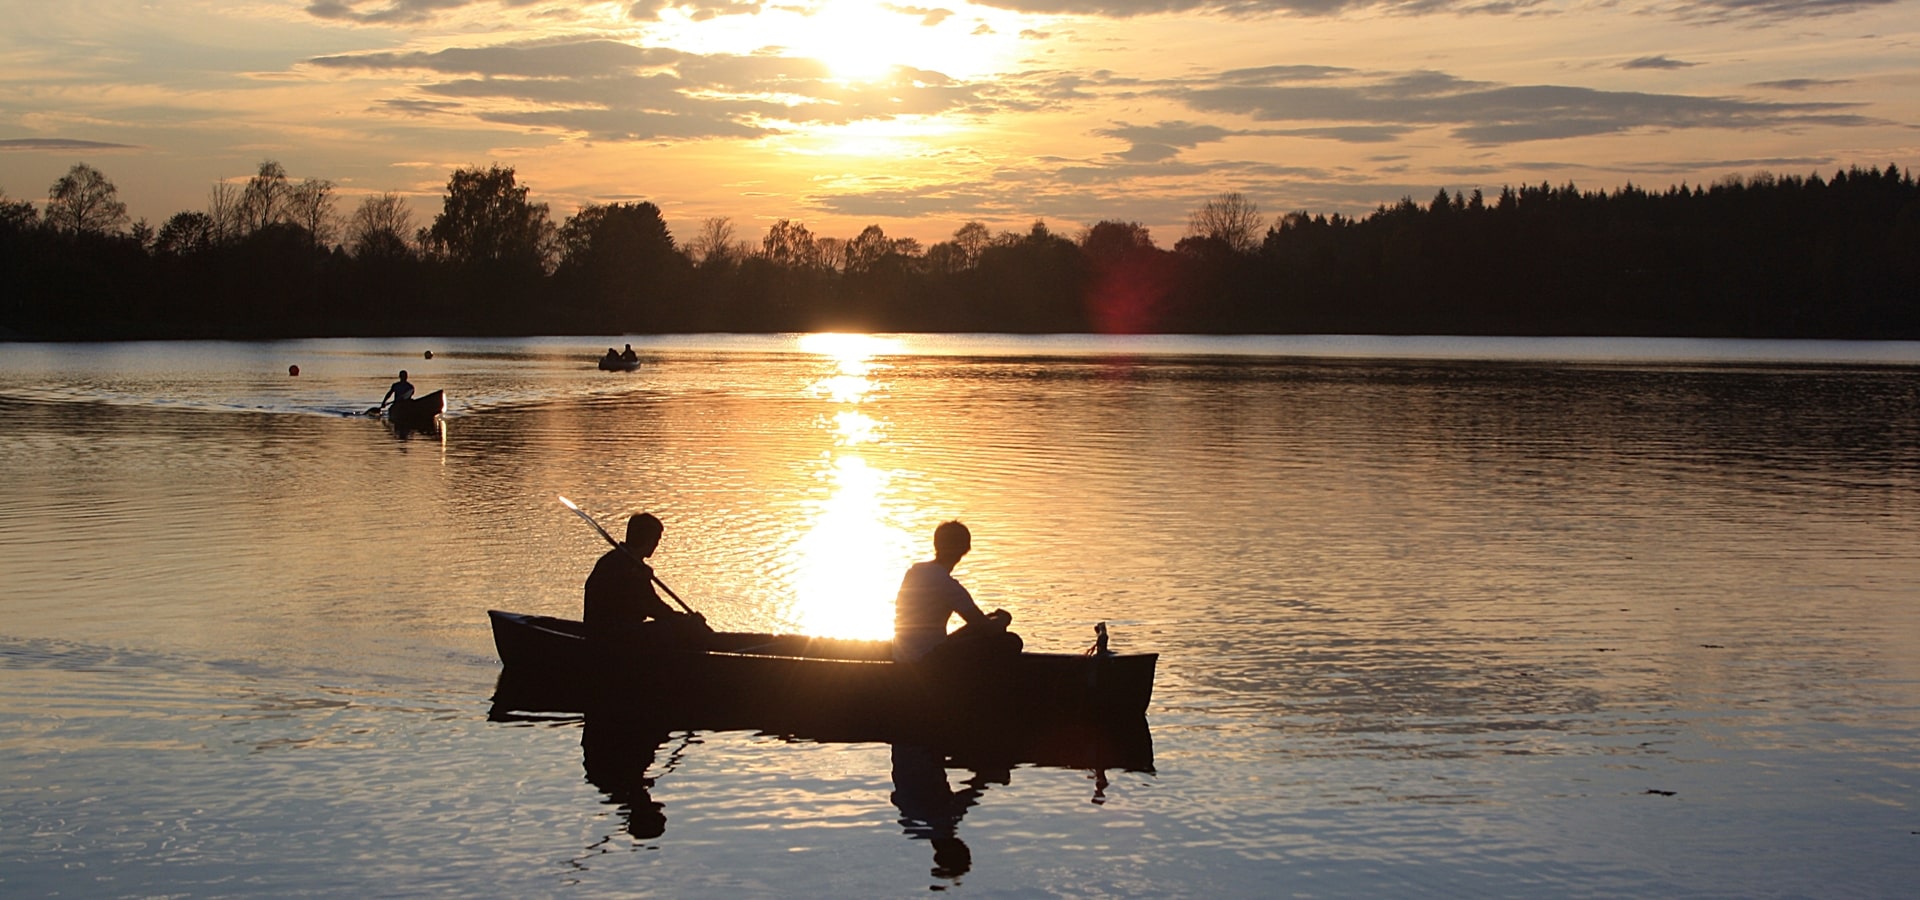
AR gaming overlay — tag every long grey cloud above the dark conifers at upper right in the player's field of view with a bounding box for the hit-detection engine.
[1164,71,1878,146]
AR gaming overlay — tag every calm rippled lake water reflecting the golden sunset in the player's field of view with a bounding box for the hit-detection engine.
[0,336,1920,898]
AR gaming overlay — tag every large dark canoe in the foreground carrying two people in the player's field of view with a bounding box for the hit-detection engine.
[488,610,1160,735]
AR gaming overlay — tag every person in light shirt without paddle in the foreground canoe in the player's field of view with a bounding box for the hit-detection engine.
[893,522,1021,662]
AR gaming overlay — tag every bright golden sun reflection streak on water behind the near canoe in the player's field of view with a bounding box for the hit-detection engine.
[789,334,916,637]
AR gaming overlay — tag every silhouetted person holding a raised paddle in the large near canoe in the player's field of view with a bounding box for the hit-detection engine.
[582,512,712,647]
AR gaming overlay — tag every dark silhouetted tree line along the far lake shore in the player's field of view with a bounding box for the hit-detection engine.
[0,159,1920,340]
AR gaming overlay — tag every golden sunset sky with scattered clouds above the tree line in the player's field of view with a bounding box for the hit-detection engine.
[0,0,1920,248]
